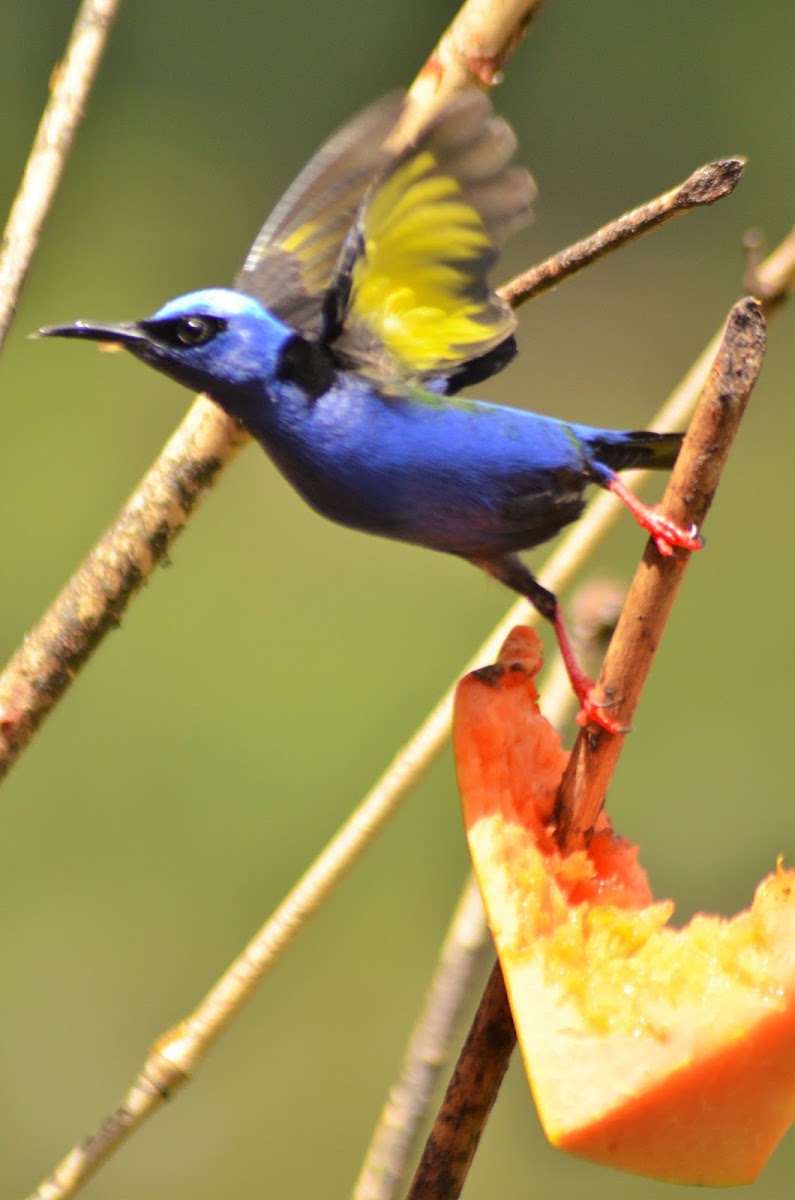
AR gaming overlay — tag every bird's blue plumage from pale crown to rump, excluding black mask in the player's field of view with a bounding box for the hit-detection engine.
[138,289,624,557]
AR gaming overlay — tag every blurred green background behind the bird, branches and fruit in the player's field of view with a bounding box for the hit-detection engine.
[0,0,795,1200]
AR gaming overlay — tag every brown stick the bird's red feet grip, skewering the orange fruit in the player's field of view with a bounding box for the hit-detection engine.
[407,292,765,1200]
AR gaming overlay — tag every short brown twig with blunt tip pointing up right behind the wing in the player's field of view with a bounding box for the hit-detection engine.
[501,158,746,308]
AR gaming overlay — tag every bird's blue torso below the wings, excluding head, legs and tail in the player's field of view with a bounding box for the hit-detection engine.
[245,376,588,557]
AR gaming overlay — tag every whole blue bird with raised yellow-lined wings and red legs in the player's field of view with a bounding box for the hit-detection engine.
[40,90,700,730]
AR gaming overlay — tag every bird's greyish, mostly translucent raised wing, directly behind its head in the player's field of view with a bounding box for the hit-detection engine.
[234,92,405,337]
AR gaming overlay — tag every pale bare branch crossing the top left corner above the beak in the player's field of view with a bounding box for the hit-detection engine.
[0,0,120,348]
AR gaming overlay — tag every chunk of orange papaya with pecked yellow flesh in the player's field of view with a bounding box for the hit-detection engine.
[454,629,795,1184]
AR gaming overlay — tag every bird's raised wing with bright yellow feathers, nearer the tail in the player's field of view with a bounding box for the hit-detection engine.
[322,89,536,382]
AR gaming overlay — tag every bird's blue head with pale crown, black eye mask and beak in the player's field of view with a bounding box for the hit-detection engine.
[40,288,333,424]
